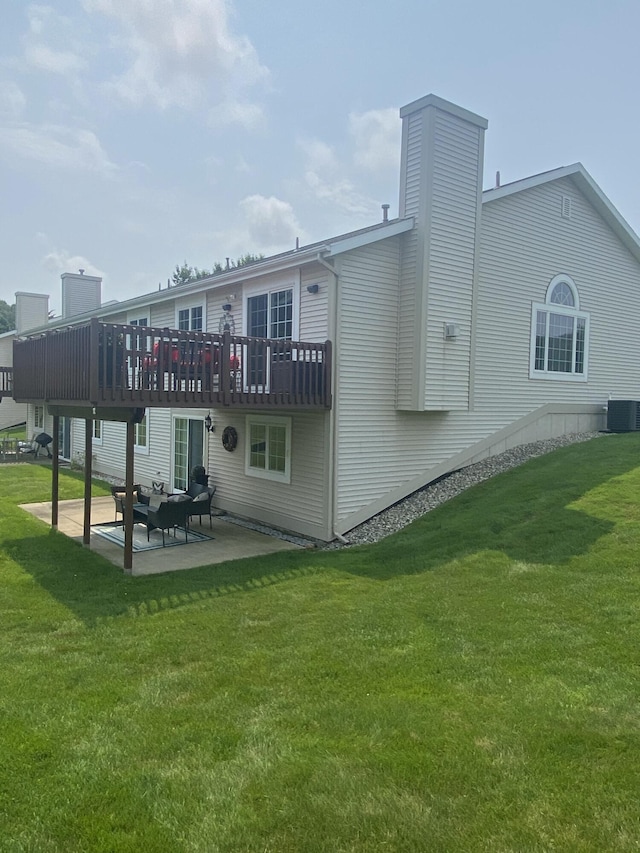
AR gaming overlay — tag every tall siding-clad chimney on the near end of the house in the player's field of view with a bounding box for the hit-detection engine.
[398,95,488,411]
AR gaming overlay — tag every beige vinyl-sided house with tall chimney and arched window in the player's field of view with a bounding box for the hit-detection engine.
[8,95,640,540]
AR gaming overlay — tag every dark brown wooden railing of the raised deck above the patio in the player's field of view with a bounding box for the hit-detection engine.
[13,320,331,408]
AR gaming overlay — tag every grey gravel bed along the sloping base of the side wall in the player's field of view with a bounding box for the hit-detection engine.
[325,432,607,549]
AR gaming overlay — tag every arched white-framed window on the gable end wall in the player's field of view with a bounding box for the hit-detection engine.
[529,275,589,381]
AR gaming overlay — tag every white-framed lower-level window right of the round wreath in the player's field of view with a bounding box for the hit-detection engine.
[245,417,291,483]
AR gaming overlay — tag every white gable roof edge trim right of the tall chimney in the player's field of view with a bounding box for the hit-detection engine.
[482,163,640,262]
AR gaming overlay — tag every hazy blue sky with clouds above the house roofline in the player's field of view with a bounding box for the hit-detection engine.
[0,0,640,313]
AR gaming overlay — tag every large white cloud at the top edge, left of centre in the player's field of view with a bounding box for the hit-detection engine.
[83,0,268,125]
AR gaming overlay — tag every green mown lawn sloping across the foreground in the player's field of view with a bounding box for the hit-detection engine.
[0,434,640,853]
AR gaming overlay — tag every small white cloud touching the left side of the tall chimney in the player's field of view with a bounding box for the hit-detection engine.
[349,109,401,172]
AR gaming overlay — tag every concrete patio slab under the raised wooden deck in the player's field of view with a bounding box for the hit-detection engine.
[22,496,302,575]
